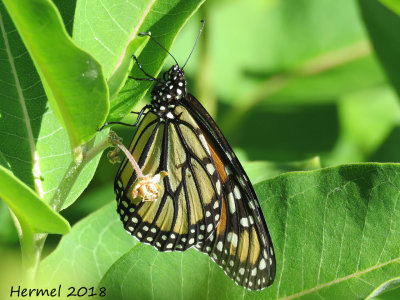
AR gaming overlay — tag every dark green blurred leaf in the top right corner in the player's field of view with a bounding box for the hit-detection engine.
[359,0,400,95]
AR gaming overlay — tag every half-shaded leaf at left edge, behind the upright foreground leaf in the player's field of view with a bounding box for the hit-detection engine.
[0,2,106,210]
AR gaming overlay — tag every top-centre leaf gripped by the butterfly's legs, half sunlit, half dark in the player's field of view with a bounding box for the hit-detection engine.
[74,0,204,121]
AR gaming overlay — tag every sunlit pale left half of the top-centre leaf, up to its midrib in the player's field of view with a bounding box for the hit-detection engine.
[73,0,155,101]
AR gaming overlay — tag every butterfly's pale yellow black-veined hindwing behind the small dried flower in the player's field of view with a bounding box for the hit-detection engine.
[114,107,222,251]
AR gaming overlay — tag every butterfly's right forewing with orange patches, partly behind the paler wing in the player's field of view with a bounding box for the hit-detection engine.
[183,94,276,290]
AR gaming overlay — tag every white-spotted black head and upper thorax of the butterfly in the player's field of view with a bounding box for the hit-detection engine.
[151,65,186,104]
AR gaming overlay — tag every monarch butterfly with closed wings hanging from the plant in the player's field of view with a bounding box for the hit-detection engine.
[114,21,276,290]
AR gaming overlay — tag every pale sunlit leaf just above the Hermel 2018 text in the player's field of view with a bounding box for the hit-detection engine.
[38,200,137,286]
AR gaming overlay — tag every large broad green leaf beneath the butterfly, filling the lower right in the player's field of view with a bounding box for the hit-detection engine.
[99,164,400,299]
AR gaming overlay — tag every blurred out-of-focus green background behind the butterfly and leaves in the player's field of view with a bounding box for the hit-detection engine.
[0,0,400,298]
